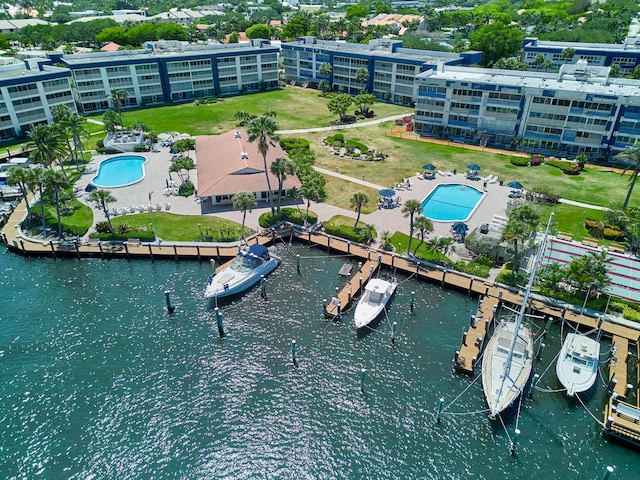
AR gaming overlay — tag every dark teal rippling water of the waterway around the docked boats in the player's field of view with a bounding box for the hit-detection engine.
[0,245,640,479]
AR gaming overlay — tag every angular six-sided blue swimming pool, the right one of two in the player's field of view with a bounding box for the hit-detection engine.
[422,184,484,222]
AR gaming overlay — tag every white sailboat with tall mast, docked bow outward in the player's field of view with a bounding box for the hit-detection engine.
[482,213,553,419]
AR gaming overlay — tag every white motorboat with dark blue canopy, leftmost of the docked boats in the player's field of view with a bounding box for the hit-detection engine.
[204,243,280,299]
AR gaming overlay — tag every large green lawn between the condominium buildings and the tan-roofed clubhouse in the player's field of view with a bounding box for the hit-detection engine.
[100,88,410,135]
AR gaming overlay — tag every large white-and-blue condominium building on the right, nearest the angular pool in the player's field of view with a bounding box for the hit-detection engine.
[414,60,640,158]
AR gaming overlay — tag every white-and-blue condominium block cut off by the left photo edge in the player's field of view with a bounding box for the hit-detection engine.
[0,59,76,141]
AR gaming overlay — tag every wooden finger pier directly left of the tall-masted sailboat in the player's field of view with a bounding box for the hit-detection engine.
[454,295,499,375]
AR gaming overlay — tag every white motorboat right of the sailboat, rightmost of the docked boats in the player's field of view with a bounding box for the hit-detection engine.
[556,333,600,397]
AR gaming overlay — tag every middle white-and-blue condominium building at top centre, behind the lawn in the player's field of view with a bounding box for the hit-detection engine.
[282,37,482,105]
